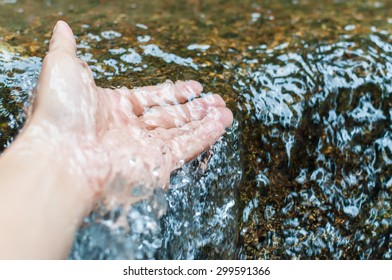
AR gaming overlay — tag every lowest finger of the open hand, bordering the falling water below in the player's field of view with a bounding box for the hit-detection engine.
[169,107,233,169]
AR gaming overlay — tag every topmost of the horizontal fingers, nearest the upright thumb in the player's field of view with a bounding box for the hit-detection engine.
[119,81,203,115]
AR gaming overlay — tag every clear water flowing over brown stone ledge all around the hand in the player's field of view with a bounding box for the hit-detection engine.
[0,0,392,259]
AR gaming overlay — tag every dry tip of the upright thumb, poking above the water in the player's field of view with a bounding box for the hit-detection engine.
[49,20,76,56]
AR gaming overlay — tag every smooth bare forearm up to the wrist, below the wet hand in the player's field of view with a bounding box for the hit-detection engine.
[0,122,90,259]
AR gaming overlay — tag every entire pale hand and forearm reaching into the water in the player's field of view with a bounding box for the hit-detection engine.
[0,21,233,259]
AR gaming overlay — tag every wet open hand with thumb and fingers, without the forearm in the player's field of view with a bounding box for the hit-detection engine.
[32,21,233,199]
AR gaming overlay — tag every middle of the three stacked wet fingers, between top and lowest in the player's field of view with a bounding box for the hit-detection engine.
[139,94,226,129]
